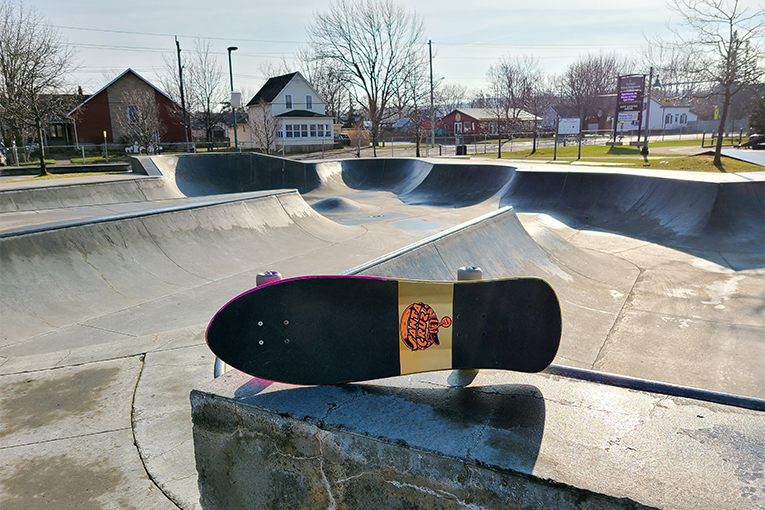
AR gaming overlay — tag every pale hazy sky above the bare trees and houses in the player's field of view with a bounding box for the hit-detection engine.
[25,0,762,96]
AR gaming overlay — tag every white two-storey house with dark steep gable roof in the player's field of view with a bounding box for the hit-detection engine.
[240,72,334,152]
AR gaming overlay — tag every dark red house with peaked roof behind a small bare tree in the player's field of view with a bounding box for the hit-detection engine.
[69,69,191,143]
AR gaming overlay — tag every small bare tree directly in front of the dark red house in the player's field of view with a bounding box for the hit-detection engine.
[115,89,167,152]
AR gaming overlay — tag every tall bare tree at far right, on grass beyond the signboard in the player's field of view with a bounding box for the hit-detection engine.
[669,0,765,164]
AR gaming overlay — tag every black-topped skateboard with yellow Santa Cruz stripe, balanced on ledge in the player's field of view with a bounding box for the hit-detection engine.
[206,276,561,385]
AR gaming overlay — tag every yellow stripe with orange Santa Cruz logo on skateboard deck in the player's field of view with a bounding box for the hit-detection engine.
[398,281,454,375]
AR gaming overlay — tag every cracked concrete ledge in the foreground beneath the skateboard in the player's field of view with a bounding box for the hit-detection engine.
[191,371,765,509]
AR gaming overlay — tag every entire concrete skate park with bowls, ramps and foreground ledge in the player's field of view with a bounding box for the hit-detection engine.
[0,154,765,508]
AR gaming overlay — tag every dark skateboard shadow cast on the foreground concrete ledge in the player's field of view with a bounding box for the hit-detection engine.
[234,377,545,474]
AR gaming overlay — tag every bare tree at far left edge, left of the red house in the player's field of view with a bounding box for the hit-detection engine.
[0,0,74,175]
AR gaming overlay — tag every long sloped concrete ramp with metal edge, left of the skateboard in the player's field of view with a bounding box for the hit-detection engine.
[0,191,365,355]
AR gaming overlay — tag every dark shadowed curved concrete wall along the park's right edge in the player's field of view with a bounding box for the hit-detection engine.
[501,171,765,260]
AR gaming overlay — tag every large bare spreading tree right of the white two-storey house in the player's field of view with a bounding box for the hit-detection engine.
[308,0,425,156]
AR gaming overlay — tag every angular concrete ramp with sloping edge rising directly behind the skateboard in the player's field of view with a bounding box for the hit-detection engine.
[349,208,640,367]
